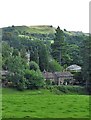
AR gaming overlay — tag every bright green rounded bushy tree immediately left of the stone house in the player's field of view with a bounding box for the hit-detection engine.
[25,61,44,89]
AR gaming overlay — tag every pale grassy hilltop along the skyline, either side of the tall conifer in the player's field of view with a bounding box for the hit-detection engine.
[3,25,88,36]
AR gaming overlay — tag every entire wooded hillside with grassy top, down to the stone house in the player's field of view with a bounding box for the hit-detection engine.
[2,26,91,90]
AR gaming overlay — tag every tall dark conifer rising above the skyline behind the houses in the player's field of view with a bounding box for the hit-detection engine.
[51,26,64,65]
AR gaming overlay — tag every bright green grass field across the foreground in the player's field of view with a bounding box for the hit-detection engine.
[2,89,89,118]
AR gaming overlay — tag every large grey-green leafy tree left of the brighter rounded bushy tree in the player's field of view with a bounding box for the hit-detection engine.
[7,56,26,90]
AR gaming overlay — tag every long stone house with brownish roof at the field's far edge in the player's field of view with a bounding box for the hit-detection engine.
[43,71,74,85]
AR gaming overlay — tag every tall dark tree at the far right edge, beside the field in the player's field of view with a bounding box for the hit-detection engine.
[81,35,91,92]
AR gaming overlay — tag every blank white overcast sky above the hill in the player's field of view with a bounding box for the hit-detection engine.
[0,0,89,33]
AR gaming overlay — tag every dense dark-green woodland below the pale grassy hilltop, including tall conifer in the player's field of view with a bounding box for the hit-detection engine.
[2,27,90,91]
